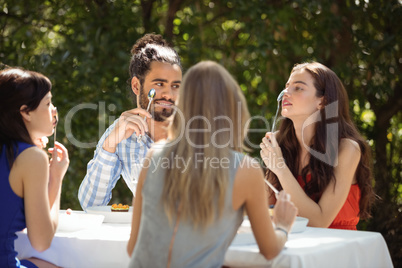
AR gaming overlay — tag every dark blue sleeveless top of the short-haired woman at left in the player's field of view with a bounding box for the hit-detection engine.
[0,142,33,267]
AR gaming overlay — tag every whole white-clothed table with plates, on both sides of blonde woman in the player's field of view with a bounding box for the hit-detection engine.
[15,206,393,267]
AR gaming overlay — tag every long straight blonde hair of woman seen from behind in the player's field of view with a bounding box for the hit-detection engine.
[161,61,250,227]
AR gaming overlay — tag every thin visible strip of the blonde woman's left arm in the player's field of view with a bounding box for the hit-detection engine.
[127,149,152,257]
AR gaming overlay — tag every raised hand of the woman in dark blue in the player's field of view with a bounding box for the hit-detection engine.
[49,141,70,181]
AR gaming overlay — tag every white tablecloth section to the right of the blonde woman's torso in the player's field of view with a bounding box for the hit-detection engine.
[225,227,393,268]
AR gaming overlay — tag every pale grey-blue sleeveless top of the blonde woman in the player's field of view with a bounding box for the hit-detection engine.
[129,149,244,268]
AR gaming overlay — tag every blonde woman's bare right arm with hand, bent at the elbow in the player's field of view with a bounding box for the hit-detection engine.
[233,157,297,259]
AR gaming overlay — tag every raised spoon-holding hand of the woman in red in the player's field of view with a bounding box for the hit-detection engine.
[260,132,286,175]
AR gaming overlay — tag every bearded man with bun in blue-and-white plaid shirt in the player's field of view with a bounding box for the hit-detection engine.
[78,34,182,210]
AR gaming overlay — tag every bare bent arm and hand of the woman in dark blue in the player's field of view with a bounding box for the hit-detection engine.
[10,144,69,251]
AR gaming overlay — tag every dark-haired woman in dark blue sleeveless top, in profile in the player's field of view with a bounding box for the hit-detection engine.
[0,68,69,267]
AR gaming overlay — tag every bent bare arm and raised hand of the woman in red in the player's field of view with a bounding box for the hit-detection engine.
[261,135,360,228]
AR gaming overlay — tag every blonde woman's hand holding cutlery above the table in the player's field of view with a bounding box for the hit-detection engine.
[273,191,297,232]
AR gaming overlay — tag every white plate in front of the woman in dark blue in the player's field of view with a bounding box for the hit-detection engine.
[57,210,105,232]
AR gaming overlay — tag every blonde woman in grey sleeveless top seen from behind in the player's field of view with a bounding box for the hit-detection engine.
[127,61,297,267]
